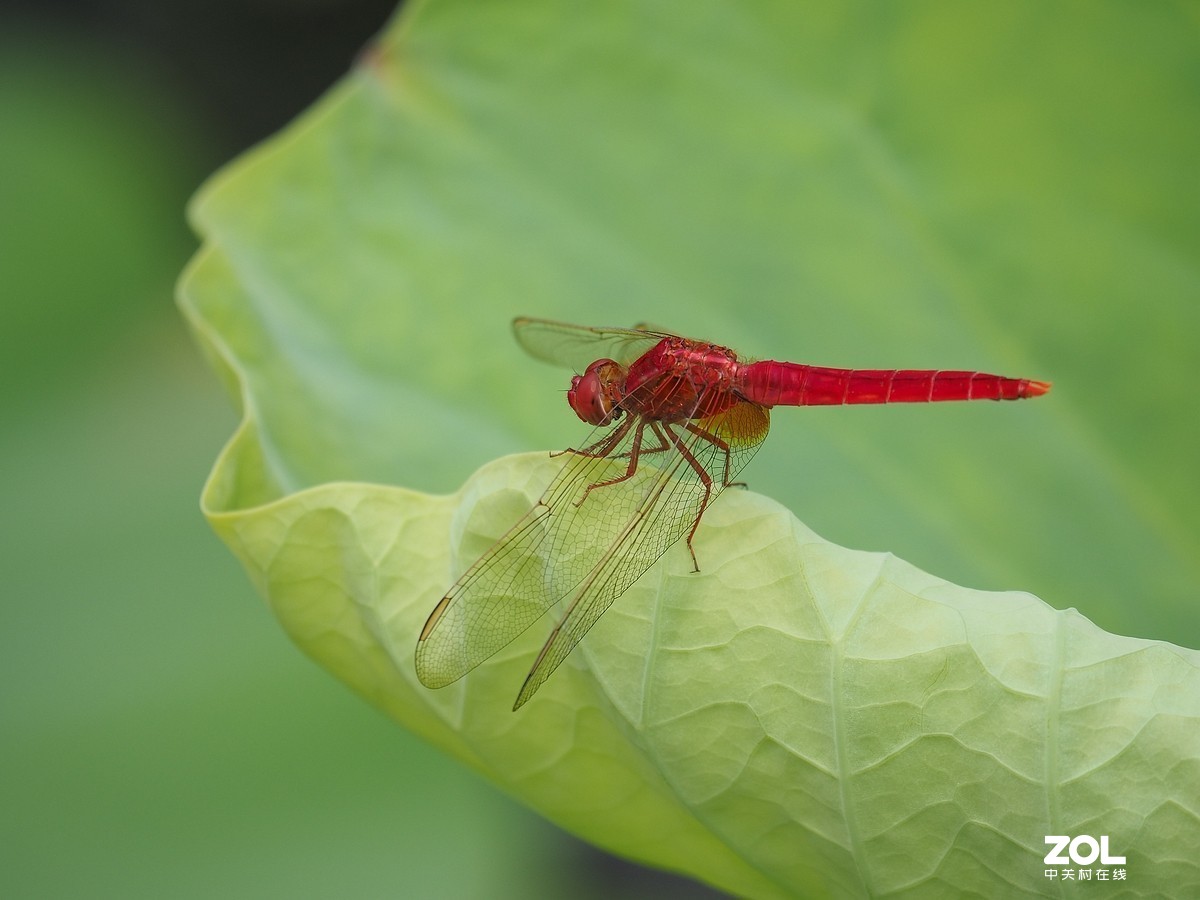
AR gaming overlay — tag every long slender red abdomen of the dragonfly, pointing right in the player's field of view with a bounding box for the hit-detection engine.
[738,360,1050,407]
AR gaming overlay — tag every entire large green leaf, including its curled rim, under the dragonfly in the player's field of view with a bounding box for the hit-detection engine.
[181,0,1200,896]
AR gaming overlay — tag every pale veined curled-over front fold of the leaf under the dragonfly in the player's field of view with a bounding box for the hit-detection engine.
[196,454,1200,896]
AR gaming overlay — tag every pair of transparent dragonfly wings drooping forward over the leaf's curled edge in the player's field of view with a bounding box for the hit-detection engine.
[416,369,769,708]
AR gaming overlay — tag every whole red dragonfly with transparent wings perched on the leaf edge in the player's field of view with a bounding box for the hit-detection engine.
[416,318,1050,709]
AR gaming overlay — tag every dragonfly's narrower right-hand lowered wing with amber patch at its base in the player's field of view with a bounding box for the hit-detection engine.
[512,402,770,709]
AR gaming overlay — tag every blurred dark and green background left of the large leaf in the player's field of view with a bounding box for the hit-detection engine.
[0,0,702,898]
